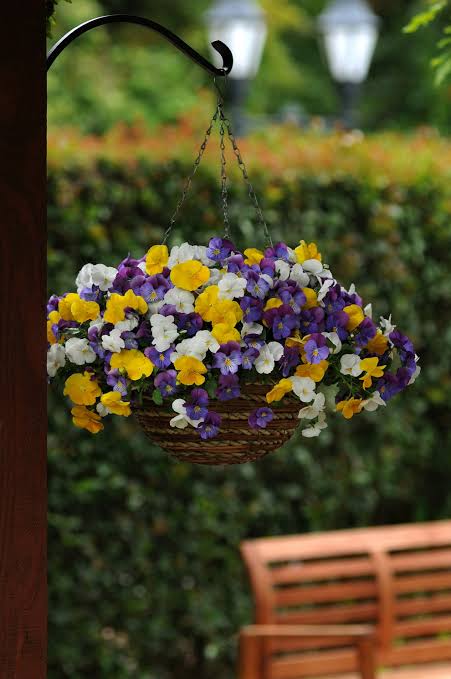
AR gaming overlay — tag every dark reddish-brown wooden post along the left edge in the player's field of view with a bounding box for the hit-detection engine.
[0,5,47,679]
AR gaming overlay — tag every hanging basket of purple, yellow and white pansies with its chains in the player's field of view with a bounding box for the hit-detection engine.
[47,101,420,464]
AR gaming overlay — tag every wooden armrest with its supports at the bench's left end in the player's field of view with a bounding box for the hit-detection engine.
[239,625,376,679]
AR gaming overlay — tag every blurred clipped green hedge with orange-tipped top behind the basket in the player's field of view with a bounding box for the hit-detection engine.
[48,121,451,679]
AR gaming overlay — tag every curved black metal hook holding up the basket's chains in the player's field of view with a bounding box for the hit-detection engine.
[47,14,233,77]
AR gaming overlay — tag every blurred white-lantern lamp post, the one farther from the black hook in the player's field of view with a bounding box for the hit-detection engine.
[318,0,380,128]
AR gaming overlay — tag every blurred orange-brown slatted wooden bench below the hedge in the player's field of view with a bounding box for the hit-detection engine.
[239,521,451,679]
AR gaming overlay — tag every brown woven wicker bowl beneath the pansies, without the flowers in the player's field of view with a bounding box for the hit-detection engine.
[133,384,300,465]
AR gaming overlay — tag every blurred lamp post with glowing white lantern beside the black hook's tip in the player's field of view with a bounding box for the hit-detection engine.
[205,0,267,136]
